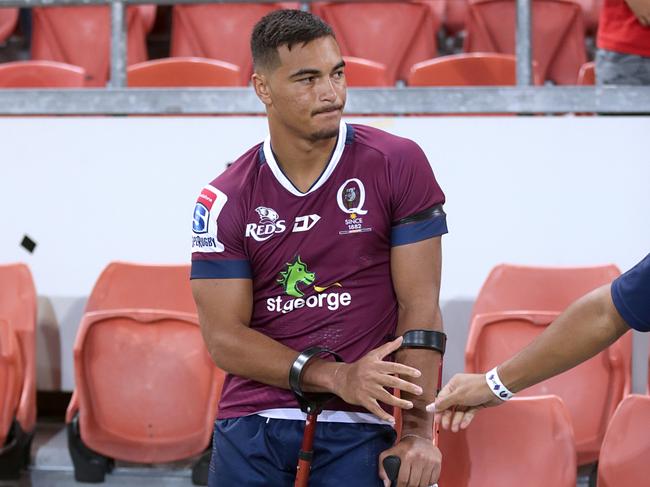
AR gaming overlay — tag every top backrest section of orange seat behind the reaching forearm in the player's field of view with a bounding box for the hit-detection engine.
[472,264,621,317]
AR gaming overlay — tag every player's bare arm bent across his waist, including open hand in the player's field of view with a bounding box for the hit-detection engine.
[192,279,419,421]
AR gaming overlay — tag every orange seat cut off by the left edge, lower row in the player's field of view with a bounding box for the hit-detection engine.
[0,264,36,478]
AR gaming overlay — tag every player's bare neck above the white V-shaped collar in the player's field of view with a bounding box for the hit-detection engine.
[271,123,337,193]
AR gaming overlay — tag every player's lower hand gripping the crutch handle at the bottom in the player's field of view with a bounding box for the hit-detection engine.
[379,435,442,487]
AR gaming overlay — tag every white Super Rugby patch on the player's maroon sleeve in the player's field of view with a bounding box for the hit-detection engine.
[192,185,228,253]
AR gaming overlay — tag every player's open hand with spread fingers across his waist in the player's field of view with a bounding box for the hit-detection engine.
[333,337,422,423]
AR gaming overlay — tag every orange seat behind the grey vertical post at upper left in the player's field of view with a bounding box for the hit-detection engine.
[32,6,147,87]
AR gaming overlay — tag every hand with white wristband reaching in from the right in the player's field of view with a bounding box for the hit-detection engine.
[427,374,503,433]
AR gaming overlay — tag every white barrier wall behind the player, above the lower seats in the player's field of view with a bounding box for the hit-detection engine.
[0,117,650,390]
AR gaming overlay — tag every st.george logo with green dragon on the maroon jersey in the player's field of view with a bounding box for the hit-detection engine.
[266,256,352,314]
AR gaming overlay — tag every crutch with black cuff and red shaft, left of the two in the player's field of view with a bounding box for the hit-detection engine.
[289,347,343,487]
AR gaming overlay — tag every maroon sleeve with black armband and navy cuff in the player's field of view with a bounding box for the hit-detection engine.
[390,140,447,247]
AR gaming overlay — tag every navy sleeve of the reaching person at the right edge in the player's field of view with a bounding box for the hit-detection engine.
[612,254,650,331]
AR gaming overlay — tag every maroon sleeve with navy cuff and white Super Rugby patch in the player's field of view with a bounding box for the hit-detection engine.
[191,185,252,279]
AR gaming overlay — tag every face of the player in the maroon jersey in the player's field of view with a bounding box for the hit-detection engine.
[256,36,346,141]
